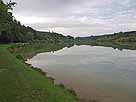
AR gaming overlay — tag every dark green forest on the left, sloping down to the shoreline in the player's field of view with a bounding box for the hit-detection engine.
[0,0,73,43]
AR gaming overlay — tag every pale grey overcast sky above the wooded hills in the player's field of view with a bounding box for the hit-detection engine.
[7,0,136,36]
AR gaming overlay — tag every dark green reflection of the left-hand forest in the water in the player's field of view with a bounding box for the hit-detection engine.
[9,41,74,60]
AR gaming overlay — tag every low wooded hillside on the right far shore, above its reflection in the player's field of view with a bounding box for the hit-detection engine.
[76,31,136,43]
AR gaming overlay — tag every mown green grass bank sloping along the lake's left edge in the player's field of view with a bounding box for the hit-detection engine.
[0,45,77,102]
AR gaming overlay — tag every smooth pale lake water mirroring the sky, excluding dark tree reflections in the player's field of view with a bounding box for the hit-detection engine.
[27,45,136,102]
